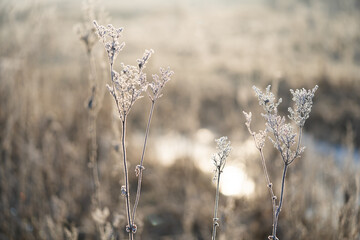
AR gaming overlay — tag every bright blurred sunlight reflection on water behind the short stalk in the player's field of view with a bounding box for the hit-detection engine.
[155,129,256,197]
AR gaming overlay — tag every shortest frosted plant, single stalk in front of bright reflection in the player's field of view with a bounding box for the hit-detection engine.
[211,137,231,240]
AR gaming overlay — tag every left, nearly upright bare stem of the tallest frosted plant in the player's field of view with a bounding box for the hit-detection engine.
[121,116,133,240]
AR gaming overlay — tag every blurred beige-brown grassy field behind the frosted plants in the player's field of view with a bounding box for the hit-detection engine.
[0,0,360,240]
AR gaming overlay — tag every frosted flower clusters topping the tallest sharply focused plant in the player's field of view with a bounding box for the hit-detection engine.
[94,21,174,121]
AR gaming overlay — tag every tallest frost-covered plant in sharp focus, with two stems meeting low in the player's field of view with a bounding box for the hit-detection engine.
[94,21,173,239]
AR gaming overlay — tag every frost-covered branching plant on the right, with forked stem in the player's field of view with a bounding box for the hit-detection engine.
[243,85,318,240]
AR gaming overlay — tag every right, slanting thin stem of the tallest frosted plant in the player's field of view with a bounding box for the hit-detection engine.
[132,100,156,225]
